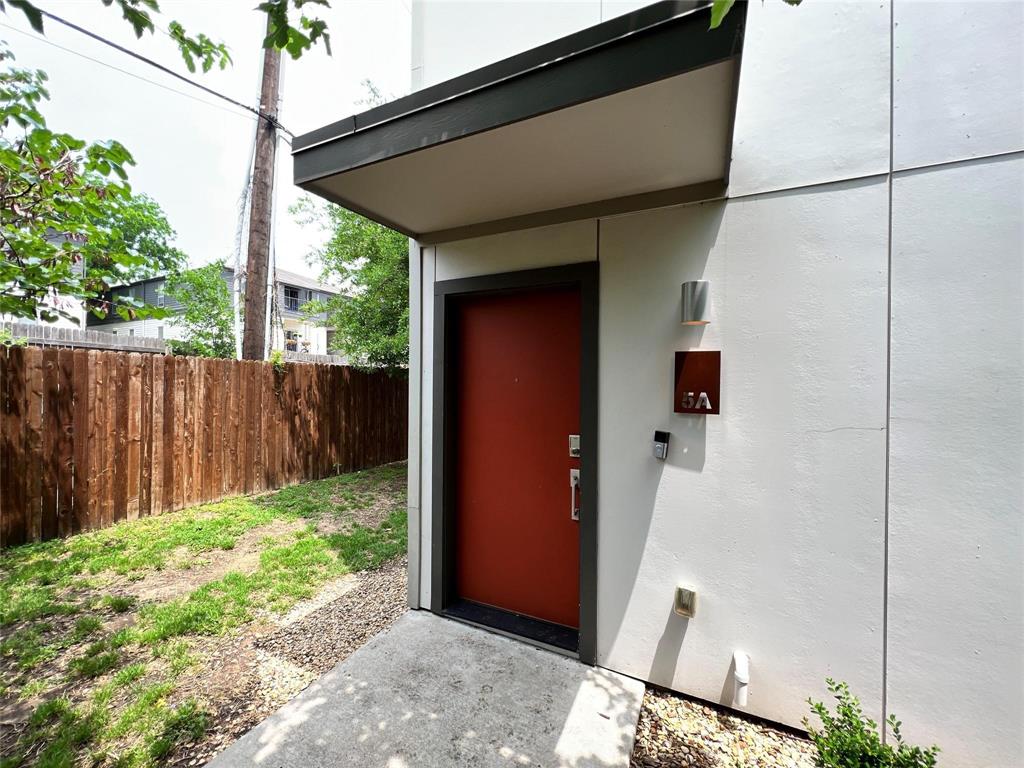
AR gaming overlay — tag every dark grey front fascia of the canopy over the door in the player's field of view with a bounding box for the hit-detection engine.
[292,0,746,189]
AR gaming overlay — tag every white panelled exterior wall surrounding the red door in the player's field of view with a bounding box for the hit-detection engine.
[413,1,1024,768]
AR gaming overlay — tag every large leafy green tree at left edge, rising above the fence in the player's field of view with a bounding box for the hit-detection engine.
[0,46,163,321]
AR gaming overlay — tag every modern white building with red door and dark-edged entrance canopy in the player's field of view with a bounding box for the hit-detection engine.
[293,0,1024,768]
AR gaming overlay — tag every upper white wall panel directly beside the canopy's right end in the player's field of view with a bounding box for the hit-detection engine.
[729,2,890,197]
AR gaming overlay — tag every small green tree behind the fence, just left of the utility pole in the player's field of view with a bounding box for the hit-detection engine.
[164,261,234,357]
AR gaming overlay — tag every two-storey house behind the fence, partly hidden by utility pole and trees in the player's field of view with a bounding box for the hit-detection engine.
[88,267,338,354]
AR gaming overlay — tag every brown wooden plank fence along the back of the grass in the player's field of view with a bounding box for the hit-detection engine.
[0,347,408,547]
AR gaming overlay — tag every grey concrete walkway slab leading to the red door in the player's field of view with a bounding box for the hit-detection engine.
[210,611,643,768]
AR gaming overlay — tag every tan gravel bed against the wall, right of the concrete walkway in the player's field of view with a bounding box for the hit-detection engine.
[630,688,814,768]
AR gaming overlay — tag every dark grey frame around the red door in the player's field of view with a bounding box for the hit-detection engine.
[430,261,599,664]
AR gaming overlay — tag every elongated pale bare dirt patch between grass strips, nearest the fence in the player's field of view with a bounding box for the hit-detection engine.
[109,520,306,602]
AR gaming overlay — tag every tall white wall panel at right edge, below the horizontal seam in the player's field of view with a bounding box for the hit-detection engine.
[888,157,1024,768]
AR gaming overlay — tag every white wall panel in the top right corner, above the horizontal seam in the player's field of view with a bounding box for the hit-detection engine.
[893,0,1024,169]
